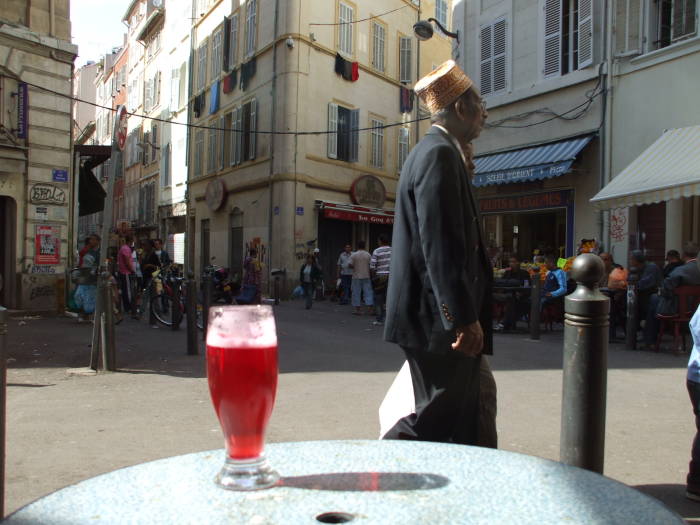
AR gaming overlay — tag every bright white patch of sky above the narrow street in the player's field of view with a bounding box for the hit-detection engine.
[70,0,129,67]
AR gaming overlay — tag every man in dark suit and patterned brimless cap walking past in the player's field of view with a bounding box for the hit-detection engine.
[384,60,497,447]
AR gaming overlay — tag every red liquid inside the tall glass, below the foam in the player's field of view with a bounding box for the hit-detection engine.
[207,345,277,459]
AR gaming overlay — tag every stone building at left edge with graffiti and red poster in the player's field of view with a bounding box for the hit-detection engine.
[0,0,77,310]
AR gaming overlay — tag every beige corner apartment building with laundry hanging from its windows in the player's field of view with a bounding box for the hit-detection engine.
[187,0,451,290]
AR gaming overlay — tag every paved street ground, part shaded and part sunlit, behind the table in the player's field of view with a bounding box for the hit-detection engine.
[6,301,700,523]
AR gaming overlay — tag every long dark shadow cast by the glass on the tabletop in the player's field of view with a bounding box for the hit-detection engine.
[278,472,450,492]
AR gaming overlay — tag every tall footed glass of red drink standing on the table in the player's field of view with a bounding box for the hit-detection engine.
[207,306,279,490]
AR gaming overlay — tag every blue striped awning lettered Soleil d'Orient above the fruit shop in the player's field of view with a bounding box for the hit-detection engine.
[473,134,594,186]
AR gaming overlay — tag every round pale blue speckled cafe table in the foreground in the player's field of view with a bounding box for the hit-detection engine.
[6,441,683,525]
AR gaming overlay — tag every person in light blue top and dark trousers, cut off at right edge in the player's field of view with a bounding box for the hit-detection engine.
[685,259,700,501]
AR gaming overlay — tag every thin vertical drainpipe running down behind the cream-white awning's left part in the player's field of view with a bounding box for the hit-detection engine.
[600,0,613,251]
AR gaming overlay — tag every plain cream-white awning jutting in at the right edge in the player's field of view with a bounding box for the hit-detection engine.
[591,126,700,209]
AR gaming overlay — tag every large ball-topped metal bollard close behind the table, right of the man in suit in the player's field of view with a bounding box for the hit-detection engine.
[559,253,610,474]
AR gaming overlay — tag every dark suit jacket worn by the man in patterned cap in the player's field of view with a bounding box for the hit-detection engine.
[384,127,493,354]
